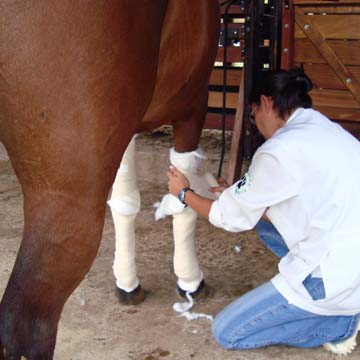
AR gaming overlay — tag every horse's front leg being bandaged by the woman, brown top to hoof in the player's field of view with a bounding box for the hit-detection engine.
[143,0,219,296]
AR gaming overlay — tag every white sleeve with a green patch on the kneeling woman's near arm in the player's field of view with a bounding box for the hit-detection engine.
[209,152,299,232]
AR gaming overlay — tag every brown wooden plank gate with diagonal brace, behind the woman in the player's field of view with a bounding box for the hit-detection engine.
[293,0,360,137]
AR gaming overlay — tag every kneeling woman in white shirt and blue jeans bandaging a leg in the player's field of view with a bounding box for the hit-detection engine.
[168,69,360,354]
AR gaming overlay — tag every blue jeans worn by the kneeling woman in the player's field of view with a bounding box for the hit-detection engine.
[212,220,359,349]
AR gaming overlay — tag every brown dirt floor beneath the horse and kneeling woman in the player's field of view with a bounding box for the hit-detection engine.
[0,131,360,360]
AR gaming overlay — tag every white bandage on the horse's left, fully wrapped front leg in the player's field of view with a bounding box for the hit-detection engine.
[108,137,140,292]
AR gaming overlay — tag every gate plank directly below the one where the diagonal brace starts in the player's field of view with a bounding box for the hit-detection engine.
[294,39,360,65]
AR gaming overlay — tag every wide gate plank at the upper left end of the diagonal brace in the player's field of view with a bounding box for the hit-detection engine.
[295,15,360,40]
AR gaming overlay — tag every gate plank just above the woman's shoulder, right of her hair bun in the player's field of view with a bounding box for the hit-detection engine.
[310,89,360,109]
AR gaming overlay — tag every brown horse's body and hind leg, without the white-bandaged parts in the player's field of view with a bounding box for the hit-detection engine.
[0,0,219,360]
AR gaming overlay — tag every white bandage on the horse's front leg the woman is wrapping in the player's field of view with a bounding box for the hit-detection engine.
[165,149,214,292]
